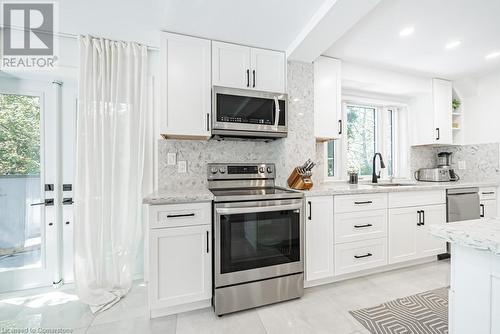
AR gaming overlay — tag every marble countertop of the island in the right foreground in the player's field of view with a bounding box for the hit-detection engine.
[429,218,500,255]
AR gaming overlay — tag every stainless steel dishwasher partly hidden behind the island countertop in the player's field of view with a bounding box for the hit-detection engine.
[438,188,481,260]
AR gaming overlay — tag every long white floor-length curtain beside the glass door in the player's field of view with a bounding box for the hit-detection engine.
[74,37,150,312]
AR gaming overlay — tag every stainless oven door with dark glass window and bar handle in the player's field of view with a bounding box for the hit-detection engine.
[214,199,304,287]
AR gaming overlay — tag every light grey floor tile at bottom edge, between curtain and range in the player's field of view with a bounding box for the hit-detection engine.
[86,315,176,334]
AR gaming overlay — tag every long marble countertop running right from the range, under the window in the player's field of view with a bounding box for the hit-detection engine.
[294,180,499,196]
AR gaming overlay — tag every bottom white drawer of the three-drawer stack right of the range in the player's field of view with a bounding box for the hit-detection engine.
[335,238,387,276]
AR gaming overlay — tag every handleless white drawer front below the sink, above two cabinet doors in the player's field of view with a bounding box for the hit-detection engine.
[389,190,446,208]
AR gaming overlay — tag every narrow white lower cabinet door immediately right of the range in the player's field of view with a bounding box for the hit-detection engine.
[305,196,334,286]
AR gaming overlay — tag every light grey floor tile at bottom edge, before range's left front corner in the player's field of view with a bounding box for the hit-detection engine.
[177,308,266,334]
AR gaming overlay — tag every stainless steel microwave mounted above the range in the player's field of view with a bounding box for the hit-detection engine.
[212,86,288,138]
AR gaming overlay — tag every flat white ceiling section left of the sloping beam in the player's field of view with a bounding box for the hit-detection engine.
[59,0,325,50]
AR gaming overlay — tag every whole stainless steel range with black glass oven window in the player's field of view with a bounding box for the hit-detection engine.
[208,164,304,315]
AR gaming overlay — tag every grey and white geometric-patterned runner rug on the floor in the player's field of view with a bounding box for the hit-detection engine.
[349,288,448,334]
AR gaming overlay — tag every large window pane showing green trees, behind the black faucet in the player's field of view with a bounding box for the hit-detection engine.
[347,105,376,175]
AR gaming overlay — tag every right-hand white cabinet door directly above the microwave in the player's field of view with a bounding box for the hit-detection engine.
[250,48,285,93]
